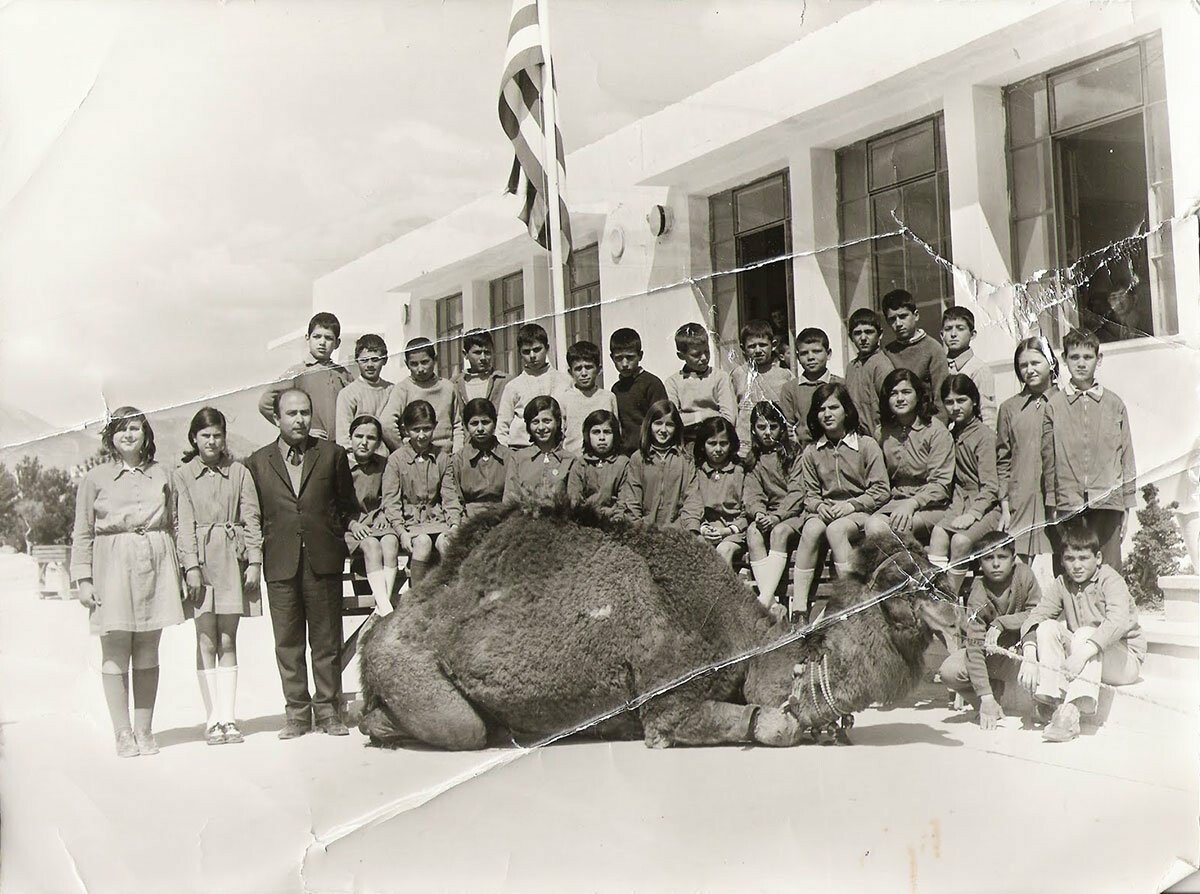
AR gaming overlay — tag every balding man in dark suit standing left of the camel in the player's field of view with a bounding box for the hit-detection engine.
[246,388,358,739]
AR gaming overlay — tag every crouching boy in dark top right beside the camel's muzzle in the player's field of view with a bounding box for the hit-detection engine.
[940,530,1042,730]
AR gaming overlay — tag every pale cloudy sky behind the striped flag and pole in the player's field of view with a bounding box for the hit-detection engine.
[0,0,820,444]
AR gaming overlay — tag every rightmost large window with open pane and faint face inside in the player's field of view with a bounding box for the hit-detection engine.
[1004,35,1178,342]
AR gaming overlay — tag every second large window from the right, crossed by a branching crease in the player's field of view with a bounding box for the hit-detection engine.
[838,114,954,329]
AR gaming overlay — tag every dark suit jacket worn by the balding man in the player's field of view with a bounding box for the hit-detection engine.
[246,438,358,581]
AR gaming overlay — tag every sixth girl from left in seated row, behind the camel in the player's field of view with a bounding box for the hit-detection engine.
[618,401,704,534]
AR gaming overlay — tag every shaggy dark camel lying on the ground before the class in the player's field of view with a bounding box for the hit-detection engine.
[359,504,959,750]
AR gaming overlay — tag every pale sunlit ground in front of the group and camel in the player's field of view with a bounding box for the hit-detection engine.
[0,556,1200,894]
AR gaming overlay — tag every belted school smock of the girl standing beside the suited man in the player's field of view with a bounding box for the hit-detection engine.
[175,456,264,617]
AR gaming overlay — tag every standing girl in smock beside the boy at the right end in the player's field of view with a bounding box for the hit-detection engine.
[996,335,1058,574]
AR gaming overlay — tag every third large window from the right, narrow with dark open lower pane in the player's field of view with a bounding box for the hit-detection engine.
[708,170,792,362]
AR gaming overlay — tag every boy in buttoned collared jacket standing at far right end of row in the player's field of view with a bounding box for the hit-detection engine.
[1042,329,1138,571]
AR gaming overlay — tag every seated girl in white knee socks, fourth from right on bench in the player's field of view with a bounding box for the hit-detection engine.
[745,401,804,608]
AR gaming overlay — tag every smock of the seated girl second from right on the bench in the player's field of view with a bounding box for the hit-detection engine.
[876,418,954,510]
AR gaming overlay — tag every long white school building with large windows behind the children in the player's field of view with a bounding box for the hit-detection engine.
[313,0,1200,499]
